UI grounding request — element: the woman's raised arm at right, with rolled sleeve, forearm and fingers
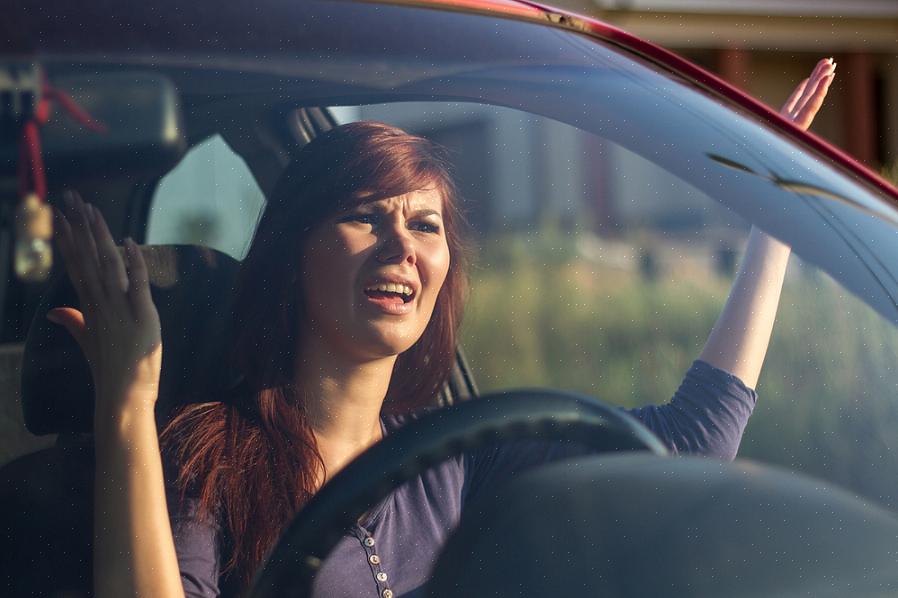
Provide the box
[630,59,835,459]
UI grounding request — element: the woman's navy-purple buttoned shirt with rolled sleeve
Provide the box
[168,361,757,598]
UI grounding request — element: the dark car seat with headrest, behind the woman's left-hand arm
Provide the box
[0,245,476,598]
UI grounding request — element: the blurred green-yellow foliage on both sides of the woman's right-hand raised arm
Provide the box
[462,234,898,506]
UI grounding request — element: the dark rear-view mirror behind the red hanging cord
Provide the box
[0,68,186,179]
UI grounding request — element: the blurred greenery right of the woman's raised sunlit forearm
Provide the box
[743,272,898,506]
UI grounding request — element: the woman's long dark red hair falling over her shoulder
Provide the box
[162,122,466,589]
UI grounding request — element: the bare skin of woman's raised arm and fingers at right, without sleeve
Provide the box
[699,59,836,388]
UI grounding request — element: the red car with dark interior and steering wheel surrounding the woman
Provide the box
[0,0,898,598]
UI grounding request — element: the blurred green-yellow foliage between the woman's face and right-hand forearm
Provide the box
[463,232,726,405]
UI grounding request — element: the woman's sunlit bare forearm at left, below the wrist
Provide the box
[94,390,183,597]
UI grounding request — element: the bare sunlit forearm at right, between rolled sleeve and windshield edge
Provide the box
[699,227,791,388]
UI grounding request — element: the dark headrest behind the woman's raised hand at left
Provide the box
[22,245,239,434]
